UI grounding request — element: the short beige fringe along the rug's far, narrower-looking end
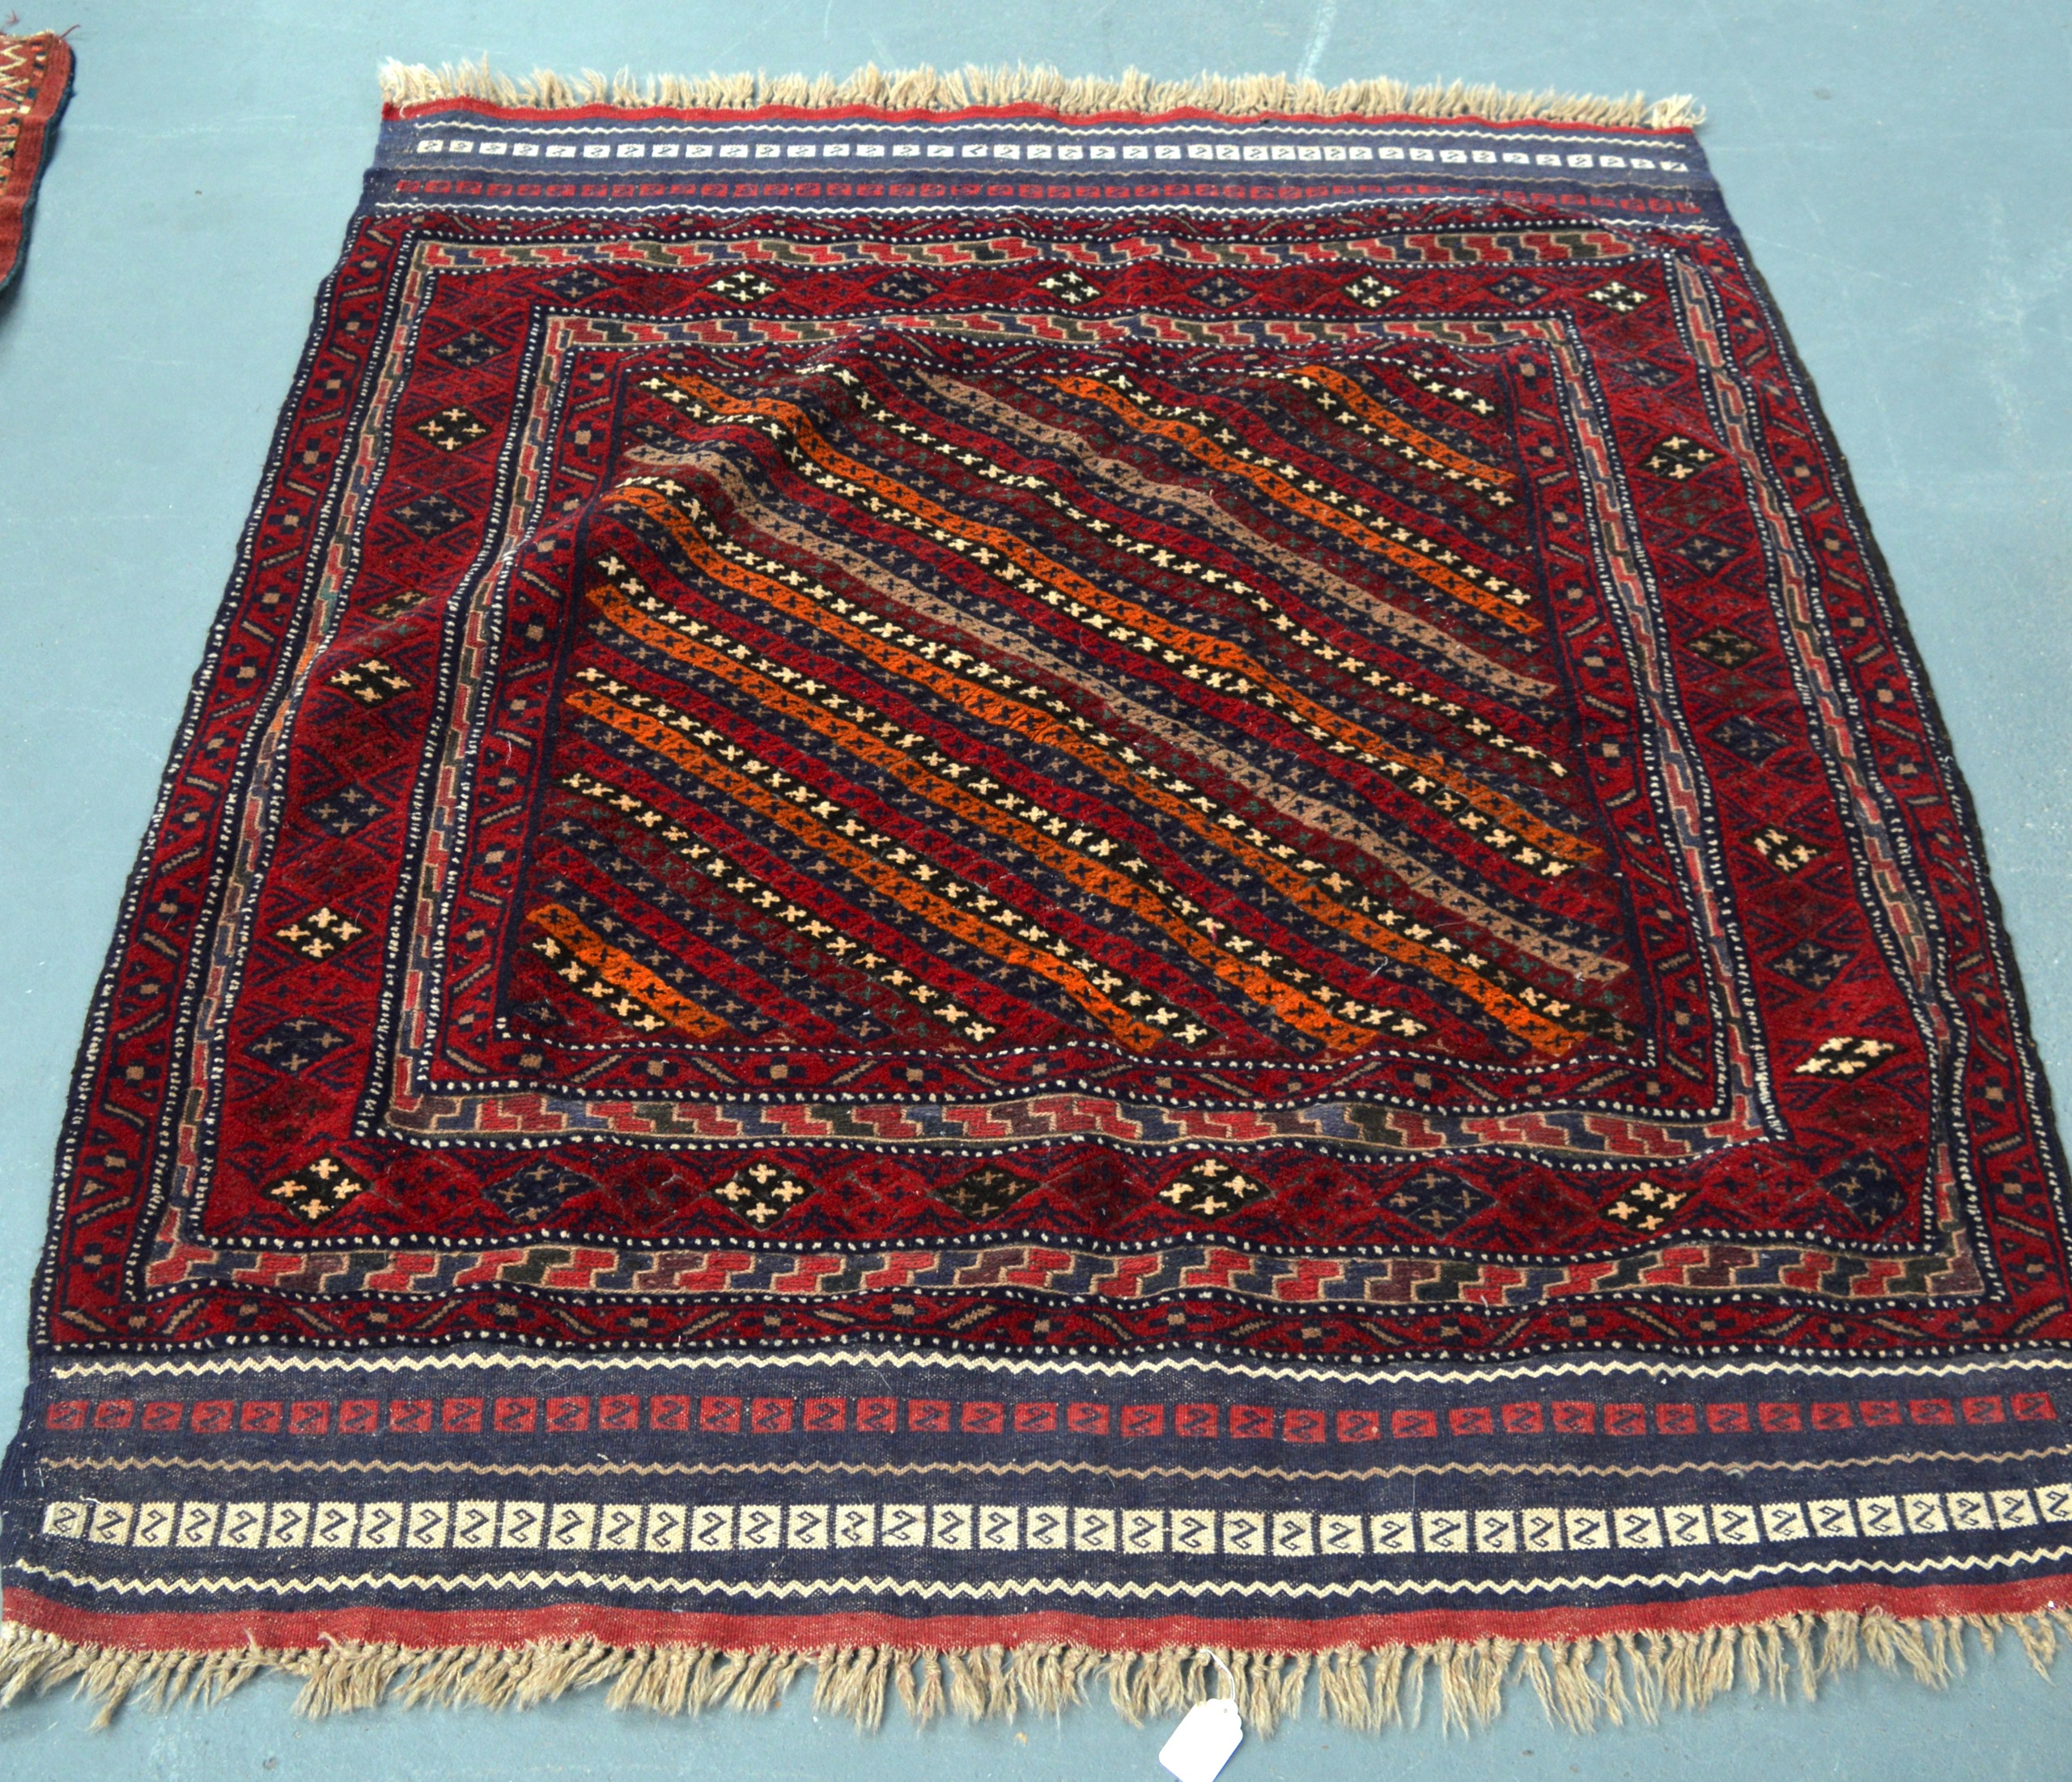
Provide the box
[381,56,1705,130]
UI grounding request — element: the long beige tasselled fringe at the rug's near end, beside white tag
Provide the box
[0,1608,2072,1734]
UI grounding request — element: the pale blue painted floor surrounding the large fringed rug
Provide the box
[0,0,2072,1782]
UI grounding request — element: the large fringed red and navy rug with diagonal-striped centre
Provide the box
[0,70,2072,1726]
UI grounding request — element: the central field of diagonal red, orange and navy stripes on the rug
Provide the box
[522,356,1639,1082]
